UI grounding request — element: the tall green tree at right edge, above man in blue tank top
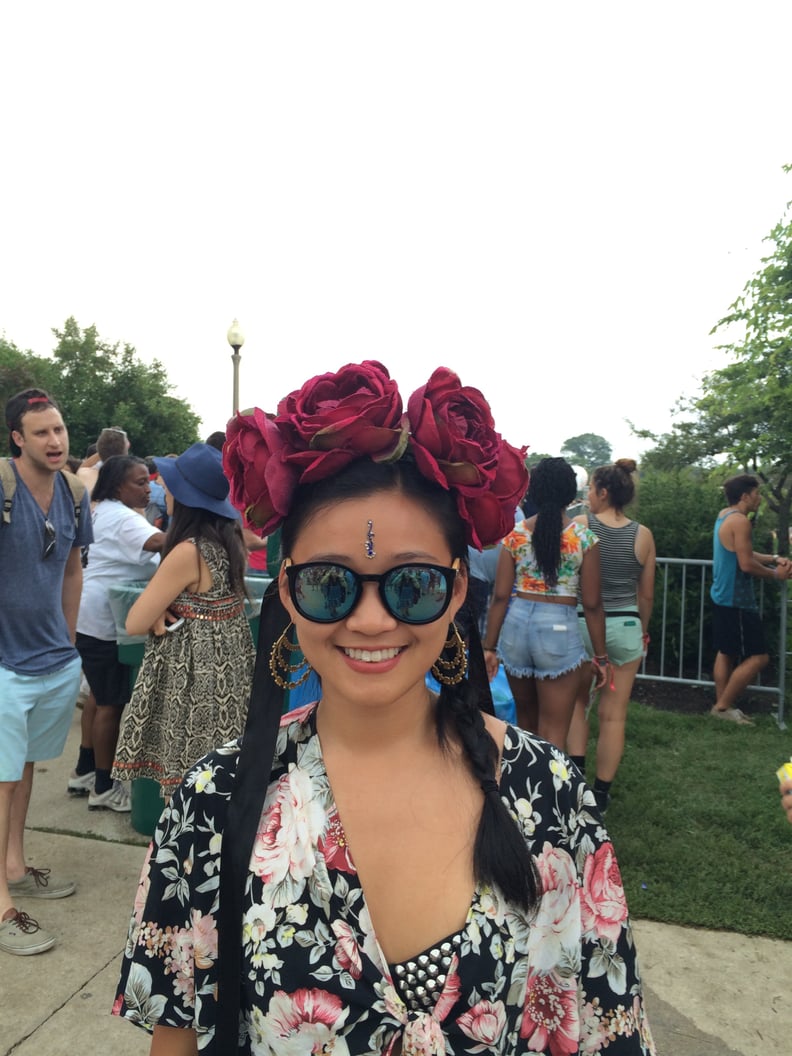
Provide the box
[639,166,792,554]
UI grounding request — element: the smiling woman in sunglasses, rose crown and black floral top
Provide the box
[114,361,655,1056]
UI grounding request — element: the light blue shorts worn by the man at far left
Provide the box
[0,657,82,781]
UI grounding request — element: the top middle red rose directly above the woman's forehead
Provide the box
[276,359,407,484]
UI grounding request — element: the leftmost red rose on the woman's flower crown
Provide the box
[223,408,298,532]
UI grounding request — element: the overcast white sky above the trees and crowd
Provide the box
[0,0,792,457]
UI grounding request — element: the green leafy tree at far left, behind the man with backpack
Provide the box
[0,318,199,456]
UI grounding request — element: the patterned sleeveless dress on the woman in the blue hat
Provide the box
[113,540,256,797]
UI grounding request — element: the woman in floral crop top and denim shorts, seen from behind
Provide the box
[484,458,609,749]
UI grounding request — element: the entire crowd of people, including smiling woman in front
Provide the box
[0,361,792,1056]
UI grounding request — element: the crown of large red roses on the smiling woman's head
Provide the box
[223,359,528,550]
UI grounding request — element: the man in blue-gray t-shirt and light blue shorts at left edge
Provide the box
[0,389,93,955]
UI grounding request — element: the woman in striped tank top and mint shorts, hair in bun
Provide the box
[567,458,655,812]
